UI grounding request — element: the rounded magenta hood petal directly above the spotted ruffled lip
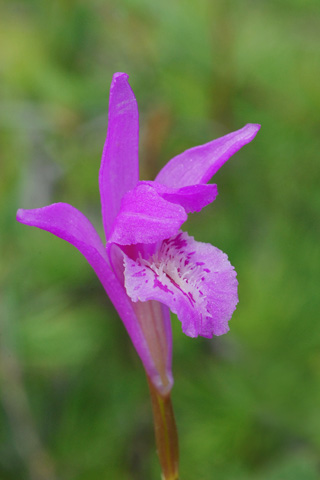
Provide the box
[108,183,187,245]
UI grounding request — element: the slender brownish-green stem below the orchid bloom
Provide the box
[148,378,179,480]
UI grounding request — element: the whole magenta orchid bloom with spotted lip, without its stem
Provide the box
[17,73,260,395]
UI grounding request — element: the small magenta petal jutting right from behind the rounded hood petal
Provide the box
[140,181,218,213]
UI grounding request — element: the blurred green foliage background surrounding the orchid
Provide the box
[0,0,320,480]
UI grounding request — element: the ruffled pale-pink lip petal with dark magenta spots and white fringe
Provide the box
[124,233,238,338]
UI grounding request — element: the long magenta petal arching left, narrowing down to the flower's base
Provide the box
[17,203,173,393]
